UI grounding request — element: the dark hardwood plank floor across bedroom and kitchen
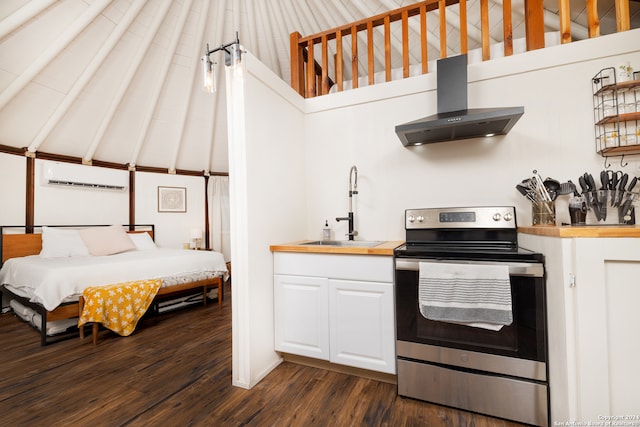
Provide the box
[0,282,520,427]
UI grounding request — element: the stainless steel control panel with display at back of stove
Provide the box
[405,206,517,230]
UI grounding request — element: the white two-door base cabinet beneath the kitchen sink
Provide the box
[274,252,395,374]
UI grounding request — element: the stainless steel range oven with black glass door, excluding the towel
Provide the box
[394,207,549,426]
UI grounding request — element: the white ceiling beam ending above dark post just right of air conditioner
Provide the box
[129,0,193,172]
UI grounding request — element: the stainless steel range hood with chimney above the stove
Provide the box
[396,54,524,146]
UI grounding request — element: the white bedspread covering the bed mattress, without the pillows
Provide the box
[0,249,227,310]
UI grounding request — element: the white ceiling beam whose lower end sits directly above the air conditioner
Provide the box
[85,0,171,166]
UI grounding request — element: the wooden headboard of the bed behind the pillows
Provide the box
[0,224,155,265]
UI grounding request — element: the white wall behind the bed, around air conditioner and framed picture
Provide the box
[0,154,205,248]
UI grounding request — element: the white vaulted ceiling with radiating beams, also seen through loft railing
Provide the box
[0,0,640,172]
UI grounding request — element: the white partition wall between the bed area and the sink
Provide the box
[227,54,306,388]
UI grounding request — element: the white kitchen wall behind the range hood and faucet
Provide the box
[300,30,640,240]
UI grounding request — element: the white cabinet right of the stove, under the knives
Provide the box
[519,234,640,423]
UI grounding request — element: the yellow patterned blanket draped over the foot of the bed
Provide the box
[78,279,162,337]
